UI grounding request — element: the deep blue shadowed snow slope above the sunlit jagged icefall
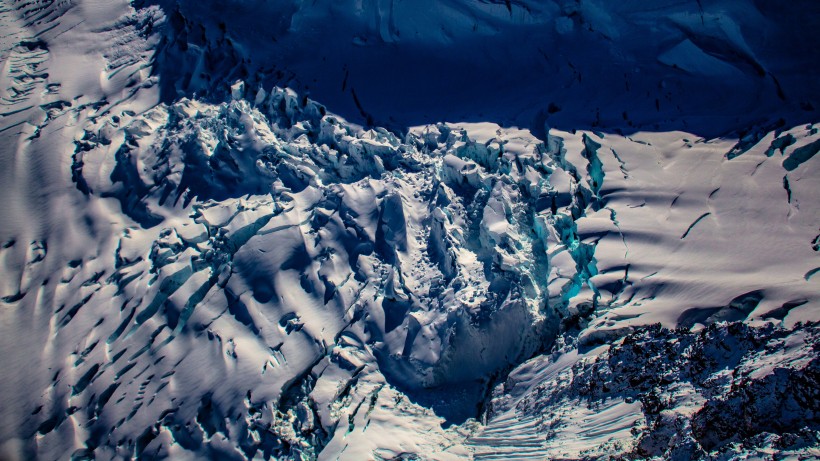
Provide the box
[138,0,820,133]
